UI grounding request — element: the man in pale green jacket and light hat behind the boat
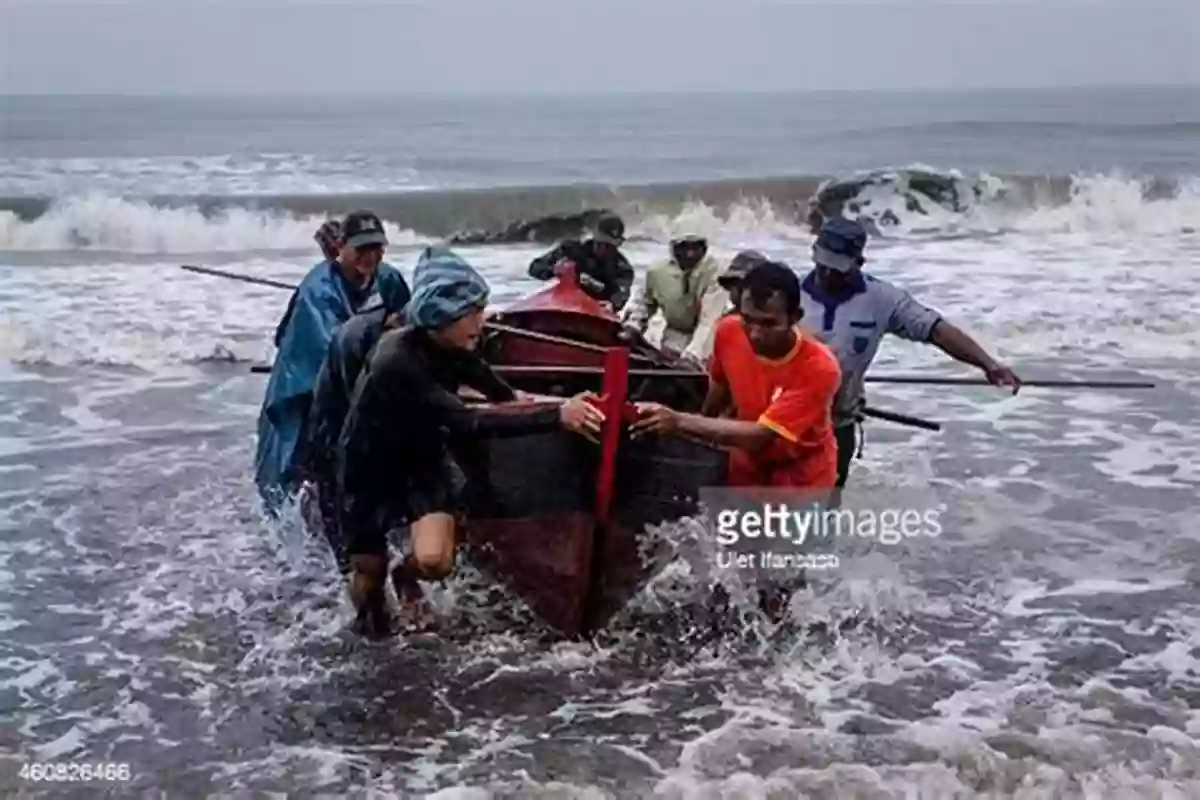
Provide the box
[625,236,725,361]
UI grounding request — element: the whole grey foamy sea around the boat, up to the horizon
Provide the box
[0,90,1200,798]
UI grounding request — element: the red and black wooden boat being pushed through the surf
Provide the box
[453,268,728,636]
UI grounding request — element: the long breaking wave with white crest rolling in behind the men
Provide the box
[0,166,1200,254]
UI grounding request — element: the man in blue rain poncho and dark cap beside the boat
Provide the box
[254,211,408,513]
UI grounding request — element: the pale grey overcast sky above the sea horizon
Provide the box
[0,0,1200,94]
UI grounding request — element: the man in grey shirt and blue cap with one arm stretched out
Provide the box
[800,217,1021,488]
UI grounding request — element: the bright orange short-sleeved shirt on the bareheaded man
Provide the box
[709,317,841,488]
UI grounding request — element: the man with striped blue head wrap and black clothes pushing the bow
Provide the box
[337,247,604,634]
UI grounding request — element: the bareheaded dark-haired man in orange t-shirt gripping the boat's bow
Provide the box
[632,261,841,491]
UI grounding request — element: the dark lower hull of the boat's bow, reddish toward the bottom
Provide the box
[456,410,727,636]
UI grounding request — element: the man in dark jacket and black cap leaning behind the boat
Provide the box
[529,213,634,312]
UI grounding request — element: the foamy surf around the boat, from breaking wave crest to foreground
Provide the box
[0,165,1200,798]
